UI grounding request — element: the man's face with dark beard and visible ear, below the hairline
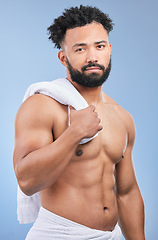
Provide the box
[59,23,111,87]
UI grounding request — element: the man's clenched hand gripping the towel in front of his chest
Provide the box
[70,105,103,138]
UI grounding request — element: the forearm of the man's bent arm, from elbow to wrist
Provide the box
[15,127,81,195]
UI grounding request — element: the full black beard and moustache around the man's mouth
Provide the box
[67,58,111,88]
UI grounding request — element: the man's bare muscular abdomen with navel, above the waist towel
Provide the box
[41,150,118,231]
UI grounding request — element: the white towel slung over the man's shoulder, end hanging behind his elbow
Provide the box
[17,78,97,224]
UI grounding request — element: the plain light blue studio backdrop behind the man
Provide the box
[0,0,158,240]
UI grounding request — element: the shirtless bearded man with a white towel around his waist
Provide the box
[13,5,145,240]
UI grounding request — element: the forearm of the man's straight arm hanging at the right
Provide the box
[118,187,145,240]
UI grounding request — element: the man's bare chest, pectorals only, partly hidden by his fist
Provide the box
[53,104,127,164]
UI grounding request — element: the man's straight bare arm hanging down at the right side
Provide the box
[116,113,145,240]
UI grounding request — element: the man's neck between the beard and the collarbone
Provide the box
[67,78,105,105]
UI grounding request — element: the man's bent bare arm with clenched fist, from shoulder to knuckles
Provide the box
[13,95,102,195]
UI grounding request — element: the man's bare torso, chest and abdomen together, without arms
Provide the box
[41,93,127,231]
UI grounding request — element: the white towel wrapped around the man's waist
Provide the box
[26,207,122,240]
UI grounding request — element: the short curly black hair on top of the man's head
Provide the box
[47,5,114,49]
